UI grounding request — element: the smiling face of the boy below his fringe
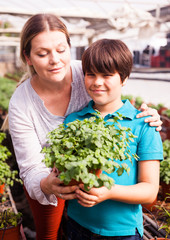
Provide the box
[85,72,126,111]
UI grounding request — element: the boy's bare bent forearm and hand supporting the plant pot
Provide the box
[76,160,160,207]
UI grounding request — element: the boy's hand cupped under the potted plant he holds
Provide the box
[76,184,109,207]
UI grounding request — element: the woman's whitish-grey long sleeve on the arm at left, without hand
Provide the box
[9,102,57,206]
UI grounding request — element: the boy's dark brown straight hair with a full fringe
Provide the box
[82,39,133,82]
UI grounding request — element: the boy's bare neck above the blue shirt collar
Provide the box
[93,100,123,117]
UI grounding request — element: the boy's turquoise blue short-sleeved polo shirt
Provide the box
[65,100,163,236]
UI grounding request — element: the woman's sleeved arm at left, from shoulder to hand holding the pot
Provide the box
[9,104,76,206]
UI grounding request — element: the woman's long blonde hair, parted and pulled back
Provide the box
[1,13,71,131]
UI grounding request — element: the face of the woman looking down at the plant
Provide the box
[26,31,70,82]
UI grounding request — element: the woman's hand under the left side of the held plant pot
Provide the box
[40,169,78,200]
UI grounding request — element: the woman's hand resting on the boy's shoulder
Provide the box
[136,103,162,131]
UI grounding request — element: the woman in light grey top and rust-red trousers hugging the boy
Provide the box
[9,14,161,240]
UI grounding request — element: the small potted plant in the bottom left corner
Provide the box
[0,208,22,240]
